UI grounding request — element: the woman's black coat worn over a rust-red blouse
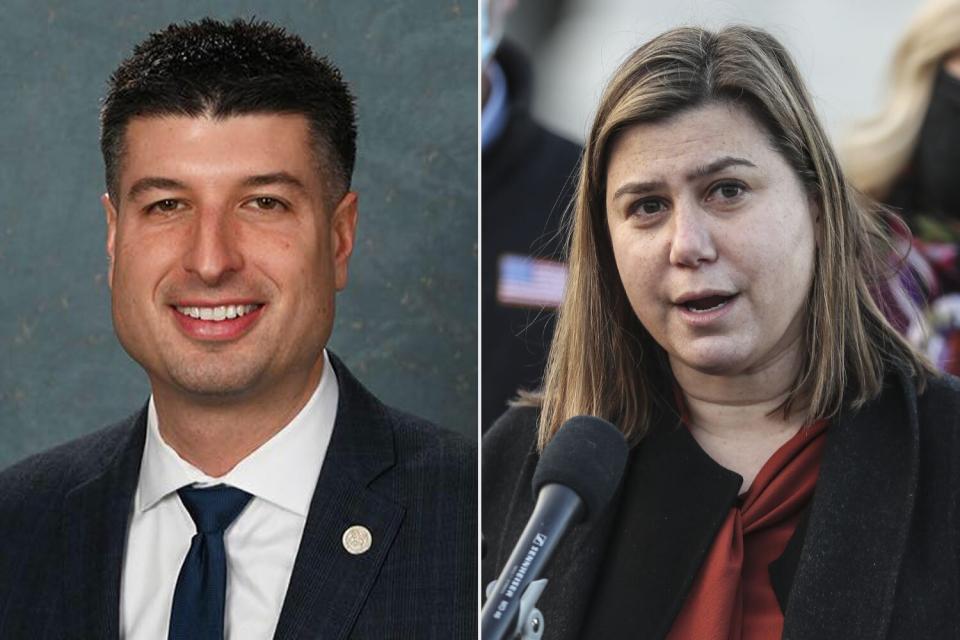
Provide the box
[481,375,960,640]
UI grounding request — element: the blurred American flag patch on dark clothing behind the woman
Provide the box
[497,253,567,307]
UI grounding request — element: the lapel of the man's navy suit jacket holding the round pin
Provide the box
[274,354,404,640]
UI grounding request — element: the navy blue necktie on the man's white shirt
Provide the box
[167,485,251,640]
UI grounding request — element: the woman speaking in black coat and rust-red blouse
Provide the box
[482,27,960,640]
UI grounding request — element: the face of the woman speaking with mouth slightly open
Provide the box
[606,103,817,376]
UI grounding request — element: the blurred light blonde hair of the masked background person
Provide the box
[840,0,960,200]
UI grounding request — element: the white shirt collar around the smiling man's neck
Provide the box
[134,350,339,517]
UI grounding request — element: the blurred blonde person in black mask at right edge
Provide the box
[841,0,960,374]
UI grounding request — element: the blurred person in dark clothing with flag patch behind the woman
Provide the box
[480,0,580,429]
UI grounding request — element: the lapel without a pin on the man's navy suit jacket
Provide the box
[63,408,147,639]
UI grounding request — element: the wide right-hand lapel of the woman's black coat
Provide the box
[783,376,919,639]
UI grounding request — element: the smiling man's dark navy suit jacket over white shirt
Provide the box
[0,357,477,640]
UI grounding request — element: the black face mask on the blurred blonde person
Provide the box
[913,68,960,218]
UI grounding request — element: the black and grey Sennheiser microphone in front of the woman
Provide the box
[480,416,627,640]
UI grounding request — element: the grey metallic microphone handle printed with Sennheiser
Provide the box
[480,484,583,640]
